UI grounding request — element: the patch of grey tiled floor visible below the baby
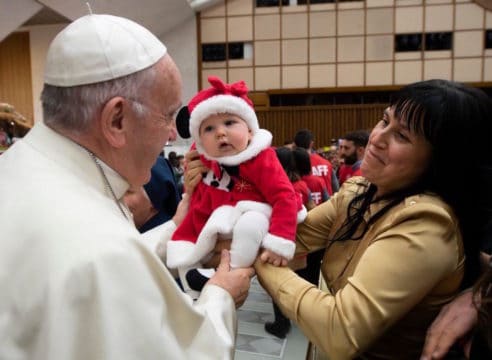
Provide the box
[235,278,308,360]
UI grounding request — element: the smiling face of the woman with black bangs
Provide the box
[361,108,432,197]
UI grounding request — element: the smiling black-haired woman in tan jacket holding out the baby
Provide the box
[255,80,492,360]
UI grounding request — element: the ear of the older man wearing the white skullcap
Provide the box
[100,96,128,148]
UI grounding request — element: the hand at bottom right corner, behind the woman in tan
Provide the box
[420,290,477,360]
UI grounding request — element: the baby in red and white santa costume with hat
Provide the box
[166,76,306,295]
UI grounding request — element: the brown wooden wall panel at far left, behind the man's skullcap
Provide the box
[0,32,33,125]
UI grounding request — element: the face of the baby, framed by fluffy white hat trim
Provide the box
[199,114,252,157]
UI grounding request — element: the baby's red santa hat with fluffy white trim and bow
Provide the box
[188,76,271,165]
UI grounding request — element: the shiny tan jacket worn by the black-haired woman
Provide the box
[255,177,464,360]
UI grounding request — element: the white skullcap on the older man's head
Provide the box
[44,15,166,87]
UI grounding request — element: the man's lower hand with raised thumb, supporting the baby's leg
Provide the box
[207,250,255,308]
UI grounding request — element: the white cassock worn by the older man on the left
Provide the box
[0,123,236,360]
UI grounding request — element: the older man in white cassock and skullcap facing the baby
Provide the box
[0,14,254,360]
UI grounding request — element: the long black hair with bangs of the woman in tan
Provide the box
[333,80,492,286]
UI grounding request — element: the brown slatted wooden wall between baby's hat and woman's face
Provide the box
[256,104,387,148]
